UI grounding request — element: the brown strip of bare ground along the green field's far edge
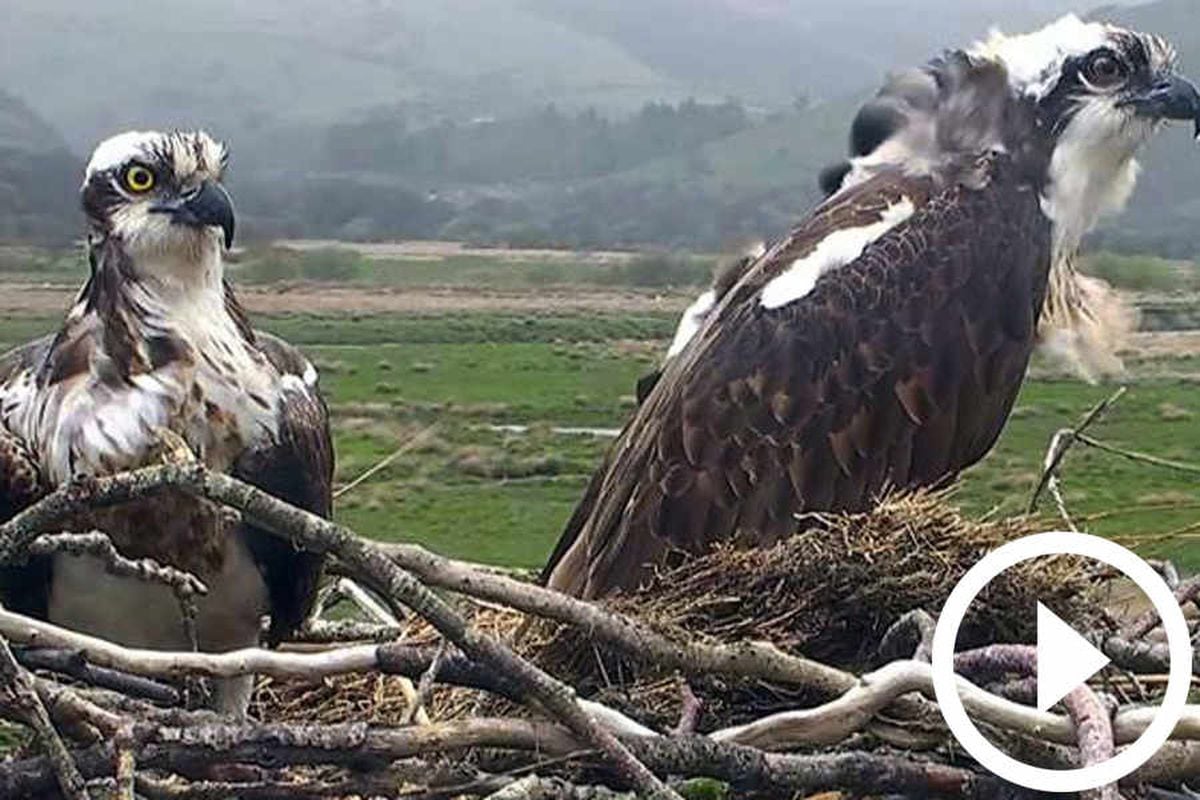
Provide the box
[0,283,692,314]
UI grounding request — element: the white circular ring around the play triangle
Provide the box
[931,531,1192,792]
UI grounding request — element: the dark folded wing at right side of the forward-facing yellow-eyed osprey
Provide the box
[234,332,334,644]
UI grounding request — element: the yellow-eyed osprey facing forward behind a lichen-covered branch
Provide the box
[0,132,334,712]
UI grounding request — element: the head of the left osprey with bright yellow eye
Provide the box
[82,131,234,261]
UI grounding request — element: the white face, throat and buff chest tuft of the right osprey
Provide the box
[972,16,1200,379]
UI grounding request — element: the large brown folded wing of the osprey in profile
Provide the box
[548,158,1050,597]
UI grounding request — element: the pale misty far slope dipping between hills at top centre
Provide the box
[532,0,1123,107]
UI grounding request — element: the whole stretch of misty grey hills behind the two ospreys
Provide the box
[9,0,1200,254]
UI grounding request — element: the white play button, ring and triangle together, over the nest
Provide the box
[931,531,1192,793]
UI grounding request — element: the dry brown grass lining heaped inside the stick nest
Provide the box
[259,493,1104,729]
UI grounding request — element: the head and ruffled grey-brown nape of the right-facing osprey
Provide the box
[822,16,1200,237]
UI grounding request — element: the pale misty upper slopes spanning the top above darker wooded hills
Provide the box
[0,0,1132,151]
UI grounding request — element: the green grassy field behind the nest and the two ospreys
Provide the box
[0,313,1200,570]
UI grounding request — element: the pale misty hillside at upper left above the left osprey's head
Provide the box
[0,0,688,151]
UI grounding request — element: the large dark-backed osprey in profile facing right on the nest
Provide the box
[544,16,1200,597]
